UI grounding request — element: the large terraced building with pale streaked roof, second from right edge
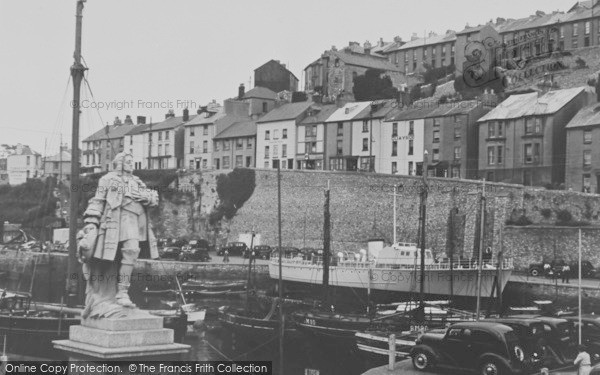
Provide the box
[478,87,587,186]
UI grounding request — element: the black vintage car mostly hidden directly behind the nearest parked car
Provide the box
[484,317,546,369]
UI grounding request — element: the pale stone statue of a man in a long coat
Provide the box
[80,152,158,318]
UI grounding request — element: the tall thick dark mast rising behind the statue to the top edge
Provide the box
[66,0,87,307]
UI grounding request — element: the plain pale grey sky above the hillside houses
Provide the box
[0,0,575,154]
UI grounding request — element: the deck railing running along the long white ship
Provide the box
[271,255,514,271]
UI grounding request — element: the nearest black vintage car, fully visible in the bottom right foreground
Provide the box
[410,322,525,375]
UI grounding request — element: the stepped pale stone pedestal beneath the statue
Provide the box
[53,312,190,373]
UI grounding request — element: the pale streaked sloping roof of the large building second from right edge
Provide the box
[478,87,585,122]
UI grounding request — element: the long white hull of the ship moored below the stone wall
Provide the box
[269,262,512,297]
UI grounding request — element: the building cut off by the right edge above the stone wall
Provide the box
[565,103,600,194]
